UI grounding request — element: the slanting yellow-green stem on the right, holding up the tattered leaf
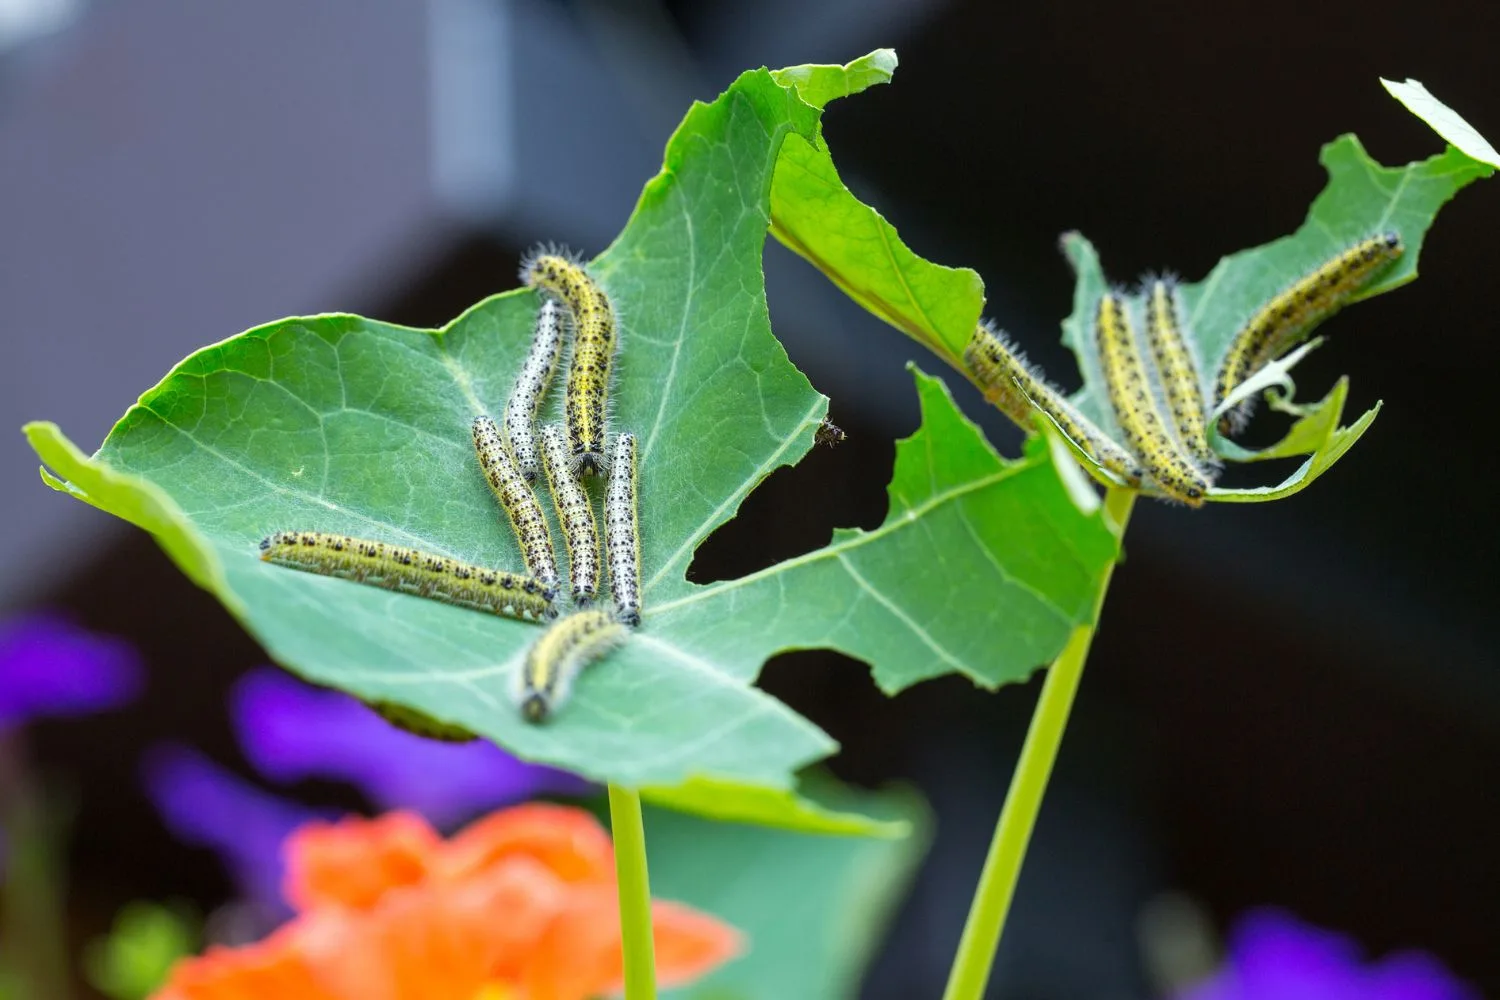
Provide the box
[942,489,1136,1000]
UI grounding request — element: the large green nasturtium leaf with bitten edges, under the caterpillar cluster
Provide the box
[27,56,1118,815]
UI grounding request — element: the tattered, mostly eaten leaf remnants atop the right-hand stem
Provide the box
[771,52,1493,502]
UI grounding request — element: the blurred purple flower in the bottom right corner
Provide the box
[1178,909,1479,1000]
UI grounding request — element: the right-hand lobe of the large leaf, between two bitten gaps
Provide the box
[657,365,1119,693]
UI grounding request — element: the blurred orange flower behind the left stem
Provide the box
[155,804,741,1000]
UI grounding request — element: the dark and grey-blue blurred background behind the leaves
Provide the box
[0,0,1500,1000]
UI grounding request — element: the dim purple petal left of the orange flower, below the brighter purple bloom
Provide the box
[143,744,332,921]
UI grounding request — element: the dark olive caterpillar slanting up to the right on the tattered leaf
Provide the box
[1214,231,1406,433]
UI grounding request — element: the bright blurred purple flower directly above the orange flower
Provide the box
[231,667,590,826]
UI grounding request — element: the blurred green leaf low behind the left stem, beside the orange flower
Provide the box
[647,792,930,1000]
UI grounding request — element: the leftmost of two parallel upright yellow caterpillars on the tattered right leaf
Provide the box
[1094,292,1209,507]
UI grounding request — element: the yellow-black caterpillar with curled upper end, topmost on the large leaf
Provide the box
[522,245,617,475]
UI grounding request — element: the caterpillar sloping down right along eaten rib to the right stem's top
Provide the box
[963,322,1143,486]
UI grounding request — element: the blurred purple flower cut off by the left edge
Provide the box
[0,615,141,730]
